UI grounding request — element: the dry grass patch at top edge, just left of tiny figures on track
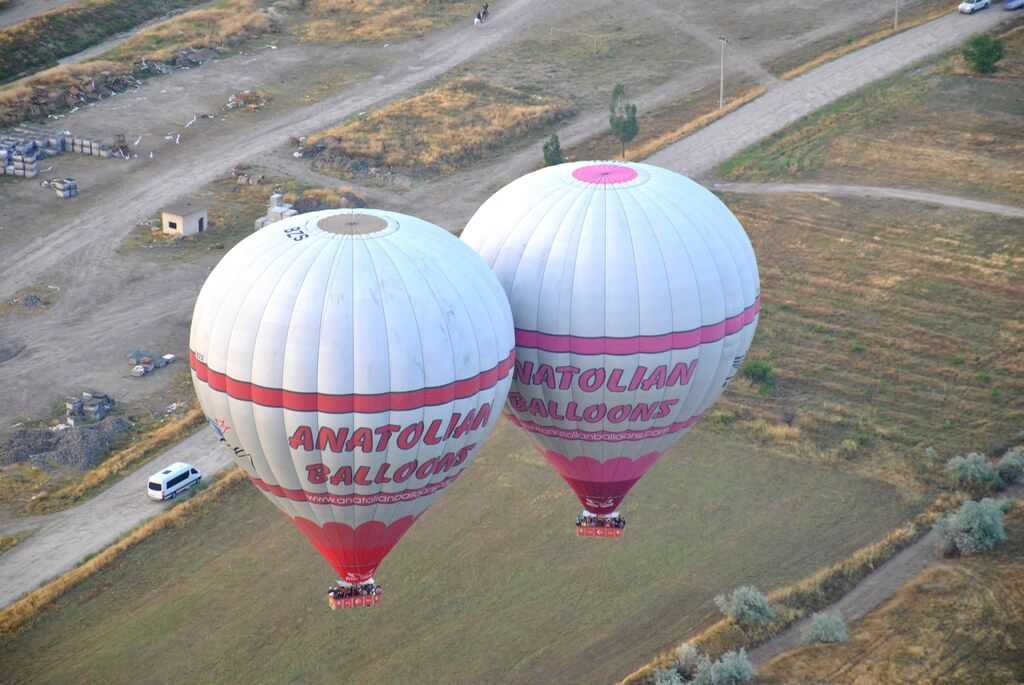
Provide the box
[292,0,480,42]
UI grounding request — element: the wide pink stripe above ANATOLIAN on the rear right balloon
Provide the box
[515,296,761,354]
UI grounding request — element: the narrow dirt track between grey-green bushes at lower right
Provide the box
[748,483,1024,665]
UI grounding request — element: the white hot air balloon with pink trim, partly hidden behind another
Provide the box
[462,162,760,537]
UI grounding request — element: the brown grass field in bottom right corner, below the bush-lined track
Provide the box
[758,507,1024,685]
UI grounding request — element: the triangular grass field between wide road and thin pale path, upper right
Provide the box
[720,27,1024,205]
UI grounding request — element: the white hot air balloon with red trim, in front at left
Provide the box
[189,209,515,606]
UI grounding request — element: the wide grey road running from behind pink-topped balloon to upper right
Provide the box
[646,9,1010,178]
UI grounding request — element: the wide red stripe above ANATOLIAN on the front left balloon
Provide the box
[188,350,515,414]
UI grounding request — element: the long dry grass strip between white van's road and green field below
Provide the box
[0,469,245,644]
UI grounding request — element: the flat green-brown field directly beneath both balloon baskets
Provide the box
[0,424,918,683]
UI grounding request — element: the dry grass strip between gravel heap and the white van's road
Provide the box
[25,405,206,514]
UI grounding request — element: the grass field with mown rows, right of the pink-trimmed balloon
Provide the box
[710,195,1024,487]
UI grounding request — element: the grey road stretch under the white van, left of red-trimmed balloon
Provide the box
[0,430,231,608]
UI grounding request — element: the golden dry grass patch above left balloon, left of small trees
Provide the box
[306,77,570,175]
